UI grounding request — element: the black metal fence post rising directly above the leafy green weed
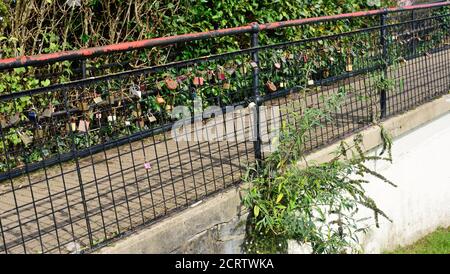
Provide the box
[251,23,262,167]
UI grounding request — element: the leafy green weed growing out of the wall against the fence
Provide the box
[243,86,395,253]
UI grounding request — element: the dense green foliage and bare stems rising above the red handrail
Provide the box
[0,0,389,57]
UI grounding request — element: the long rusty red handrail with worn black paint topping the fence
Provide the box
[0,1,450,70]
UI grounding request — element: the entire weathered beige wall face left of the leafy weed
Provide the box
[97,186,247,254]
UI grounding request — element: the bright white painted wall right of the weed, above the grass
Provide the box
[361,113,450,253]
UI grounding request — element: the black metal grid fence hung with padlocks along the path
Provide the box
[0,3,450,253]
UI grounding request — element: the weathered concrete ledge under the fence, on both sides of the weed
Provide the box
[95,95,450,253]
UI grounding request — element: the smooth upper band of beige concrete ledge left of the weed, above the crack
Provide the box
[95,187,245,254]
